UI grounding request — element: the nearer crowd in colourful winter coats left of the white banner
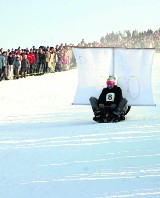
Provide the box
[0,44,74,81]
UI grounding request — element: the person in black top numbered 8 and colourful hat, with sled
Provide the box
[89,76,130,123]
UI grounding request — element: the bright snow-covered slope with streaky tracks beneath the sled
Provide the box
[0,54,160,198]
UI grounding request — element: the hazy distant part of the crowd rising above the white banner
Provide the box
[78,28,160,51]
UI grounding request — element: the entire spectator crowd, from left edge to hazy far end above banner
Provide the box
[0,28,160,81]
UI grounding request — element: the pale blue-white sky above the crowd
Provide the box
[0,0,160,49]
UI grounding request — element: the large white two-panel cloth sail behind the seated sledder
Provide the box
[73,48,154,106]
